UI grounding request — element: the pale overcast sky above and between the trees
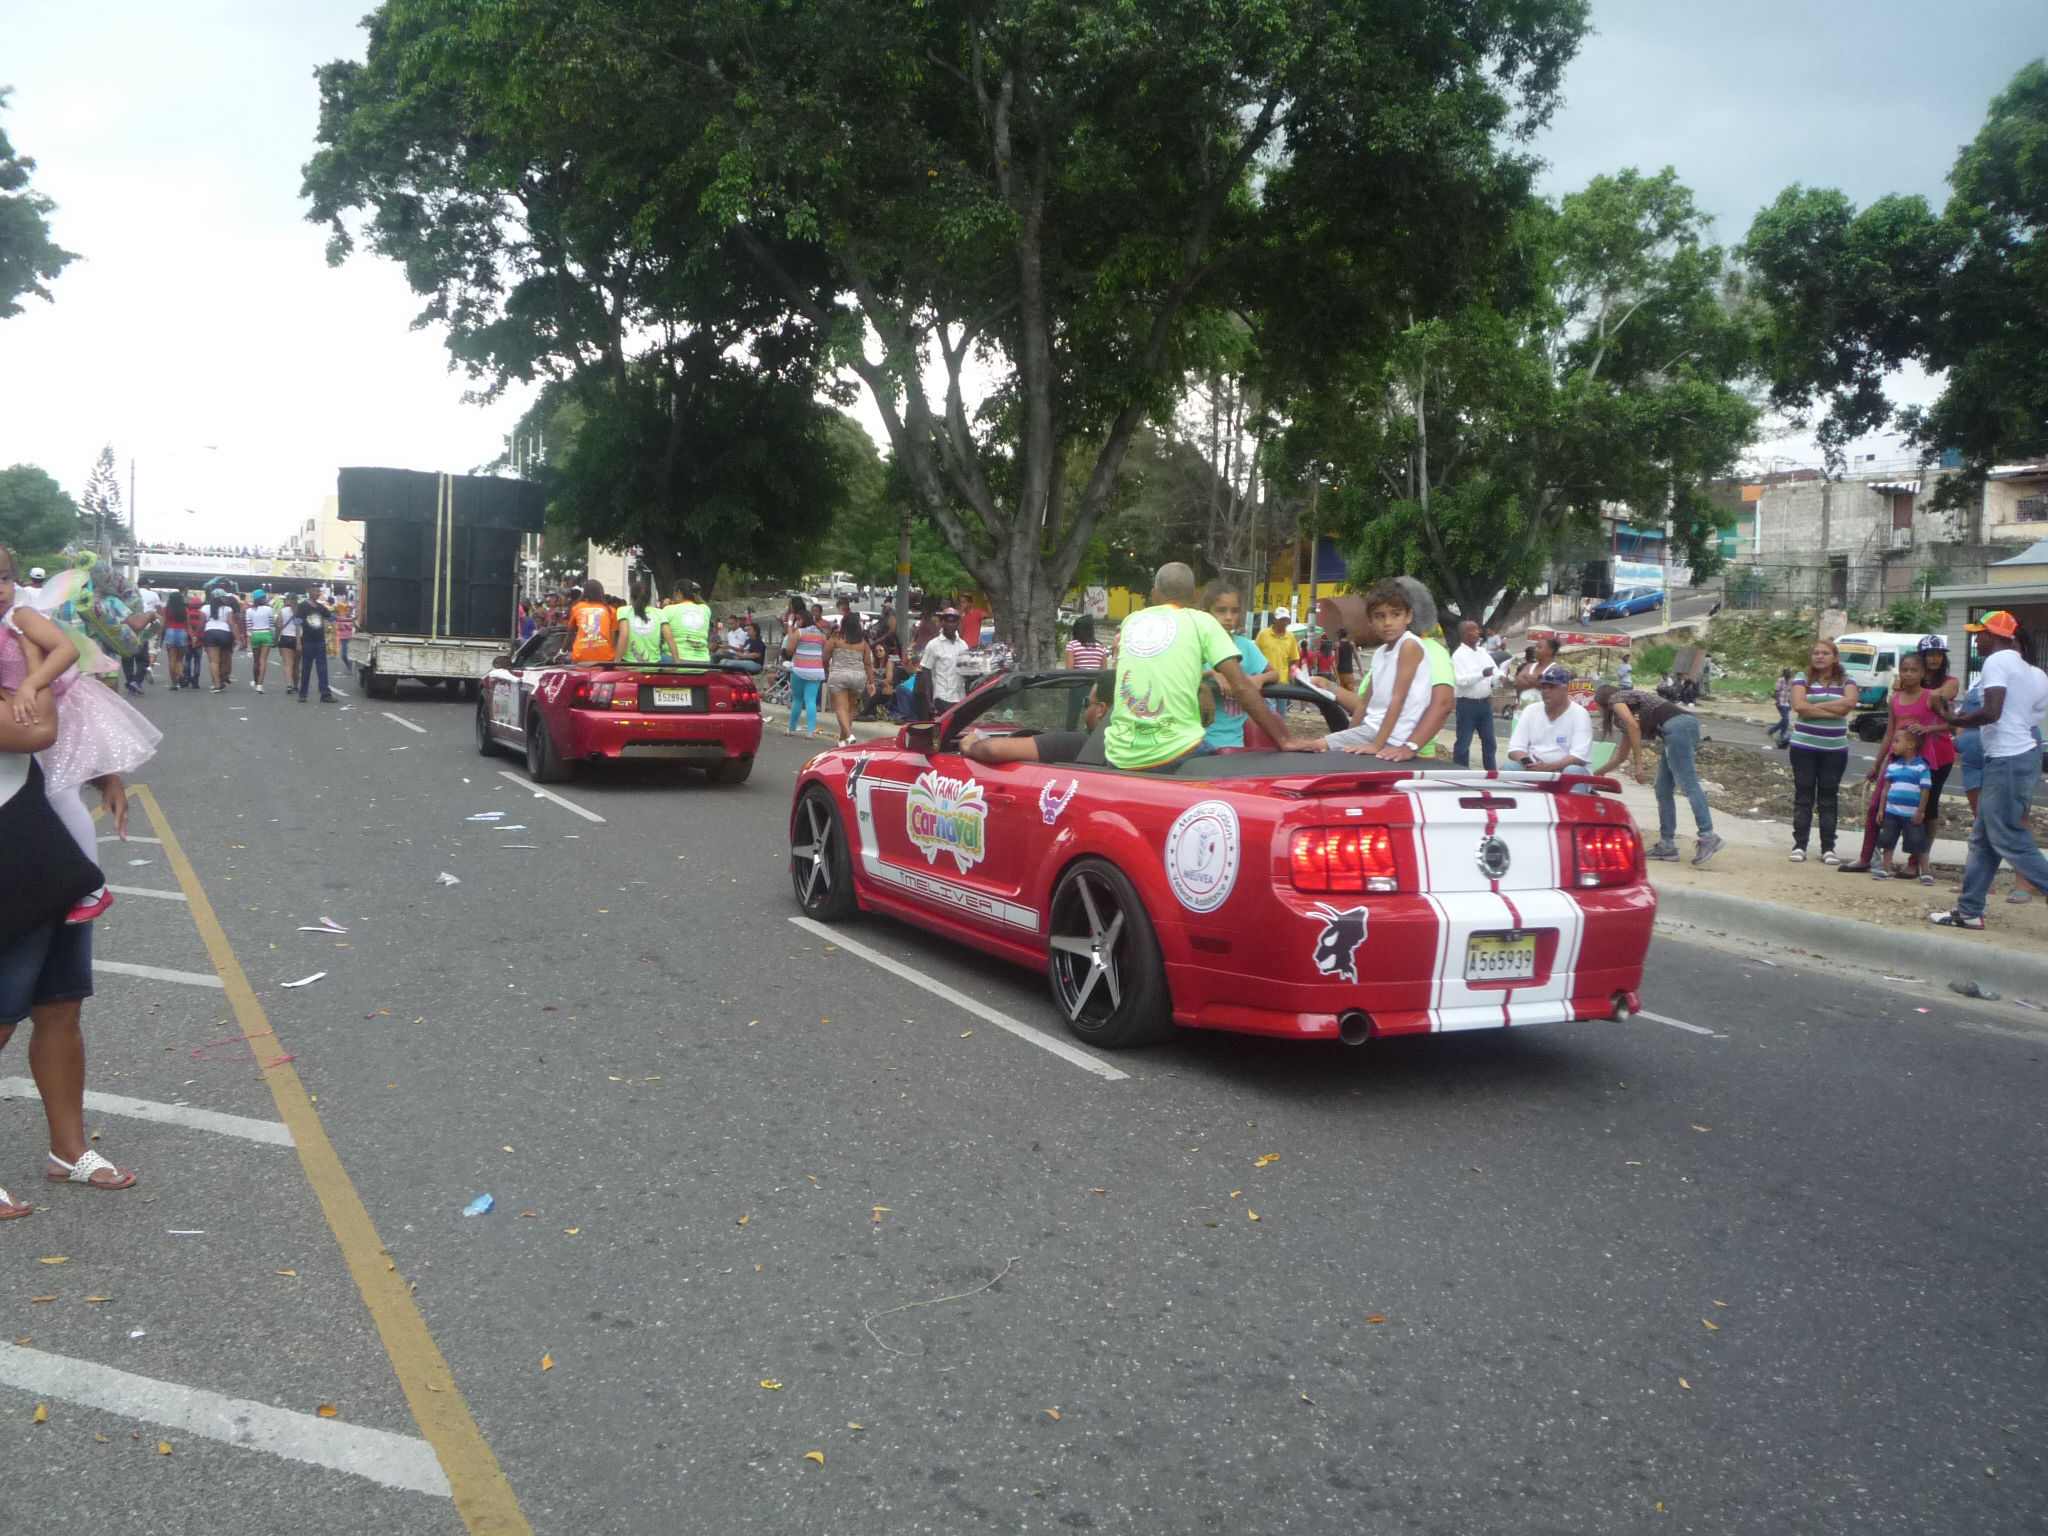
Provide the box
[0,0,2048,543]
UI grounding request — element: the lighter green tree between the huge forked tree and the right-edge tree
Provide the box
[1280,168,1757,623]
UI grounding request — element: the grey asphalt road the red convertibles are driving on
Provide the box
[0,682,2048,1536]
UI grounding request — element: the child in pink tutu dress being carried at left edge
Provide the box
[0,549,164,922]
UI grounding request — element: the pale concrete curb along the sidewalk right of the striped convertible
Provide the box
[1657,885,2048,1004]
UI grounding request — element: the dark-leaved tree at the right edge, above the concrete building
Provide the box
[1743,59,2048,498]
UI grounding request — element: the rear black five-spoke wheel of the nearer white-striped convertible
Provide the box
[1047,858,1174,1051]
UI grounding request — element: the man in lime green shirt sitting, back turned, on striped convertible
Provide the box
[1102,561,1311,768]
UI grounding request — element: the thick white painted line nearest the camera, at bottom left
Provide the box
[0,1343,453,1499]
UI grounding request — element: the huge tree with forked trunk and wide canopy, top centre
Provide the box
[307,0,1585,662]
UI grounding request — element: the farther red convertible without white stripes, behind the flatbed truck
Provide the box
[477,629,762,784]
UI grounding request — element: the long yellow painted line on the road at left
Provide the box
[129,786,532,1536]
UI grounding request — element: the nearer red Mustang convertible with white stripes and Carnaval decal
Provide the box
[791,672,1657,1047]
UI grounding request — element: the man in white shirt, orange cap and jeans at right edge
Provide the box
[1927,608,2048,928]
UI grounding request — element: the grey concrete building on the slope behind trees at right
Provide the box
[1716,463,2048,612]
